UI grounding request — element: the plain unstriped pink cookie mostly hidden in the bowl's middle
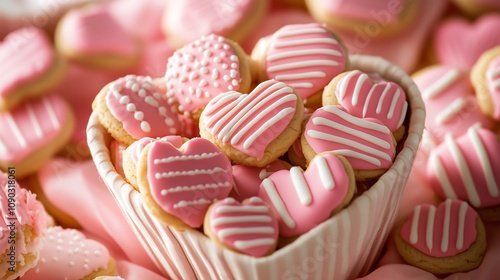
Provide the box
[229,160,291,201]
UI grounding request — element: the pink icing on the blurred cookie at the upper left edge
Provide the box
[0,27,55,98]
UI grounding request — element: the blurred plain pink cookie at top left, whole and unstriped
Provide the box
[55,6,141,71]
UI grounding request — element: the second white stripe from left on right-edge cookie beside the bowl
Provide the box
[445,133,481,207]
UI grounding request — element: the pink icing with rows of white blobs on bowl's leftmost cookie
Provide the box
[106,75,181,139]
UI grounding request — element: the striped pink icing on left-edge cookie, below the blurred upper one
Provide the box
[0,94,68,162]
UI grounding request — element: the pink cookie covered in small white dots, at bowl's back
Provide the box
[165,34,251,119]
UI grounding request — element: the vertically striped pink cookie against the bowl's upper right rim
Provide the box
[323,70,408,141]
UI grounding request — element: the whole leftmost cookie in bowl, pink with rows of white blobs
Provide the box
[92,75,181,145]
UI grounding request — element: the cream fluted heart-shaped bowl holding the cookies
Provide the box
[87,55,425,279]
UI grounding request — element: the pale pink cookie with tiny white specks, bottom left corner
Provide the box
[23,227,115,280]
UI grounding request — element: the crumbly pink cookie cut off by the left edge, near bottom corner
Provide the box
[0,171,47,280]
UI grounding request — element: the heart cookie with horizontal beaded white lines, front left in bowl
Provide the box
[137,138,233,229]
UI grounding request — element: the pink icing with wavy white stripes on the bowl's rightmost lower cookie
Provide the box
[303,105,396,170]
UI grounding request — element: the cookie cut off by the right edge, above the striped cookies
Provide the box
[470,46,500,121]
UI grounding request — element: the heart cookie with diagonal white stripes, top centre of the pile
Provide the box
[200,80,304,167]
